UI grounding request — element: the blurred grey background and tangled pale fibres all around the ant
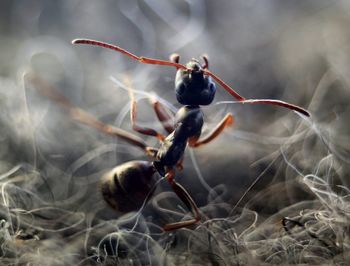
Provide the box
[0,0,350,265]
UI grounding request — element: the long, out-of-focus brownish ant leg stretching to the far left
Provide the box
[25,72,156,157]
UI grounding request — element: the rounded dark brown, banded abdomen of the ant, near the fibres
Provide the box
[101,161,159,213]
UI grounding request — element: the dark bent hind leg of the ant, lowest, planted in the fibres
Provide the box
[163,170,201,231]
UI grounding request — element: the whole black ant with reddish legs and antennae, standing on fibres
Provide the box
[30,39,310,231]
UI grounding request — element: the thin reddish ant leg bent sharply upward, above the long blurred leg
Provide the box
[125,77,165,141]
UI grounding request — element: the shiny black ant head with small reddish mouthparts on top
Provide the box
[170,55,216,105]
